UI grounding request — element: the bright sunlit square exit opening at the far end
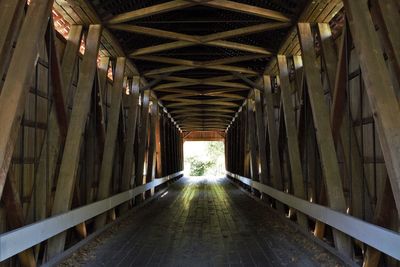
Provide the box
[183,141,225,178]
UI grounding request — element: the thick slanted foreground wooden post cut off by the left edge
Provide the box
[0,0,53,201]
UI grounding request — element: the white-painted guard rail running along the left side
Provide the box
[0,171,183,262]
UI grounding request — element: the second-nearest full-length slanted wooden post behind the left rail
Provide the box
[95,57,126,229]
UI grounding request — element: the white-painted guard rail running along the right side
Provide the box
[226,171,400,260]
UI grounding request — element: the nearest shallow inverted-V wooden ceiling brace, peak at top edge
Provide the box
[107,0,291,24]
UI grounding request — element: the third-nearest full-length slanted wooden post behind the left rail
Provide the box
[121,76,140,213]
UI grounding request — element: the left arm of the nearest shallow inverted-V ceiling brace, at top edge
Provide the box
[107,0,196,24]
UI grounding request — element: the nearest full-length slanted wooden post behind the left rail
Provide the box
[47,25,102,258]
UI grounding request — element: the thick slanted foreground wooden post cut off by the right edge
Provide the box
[343,0,400,216]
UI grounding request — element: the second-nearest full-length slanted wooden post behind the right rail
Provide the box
[276,62,308,229]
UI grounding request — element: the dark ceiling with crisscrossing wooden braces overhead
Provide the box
[91,0,307,131]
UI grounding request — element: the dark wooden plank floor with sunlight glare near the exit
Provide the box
[62,178,350,266]
